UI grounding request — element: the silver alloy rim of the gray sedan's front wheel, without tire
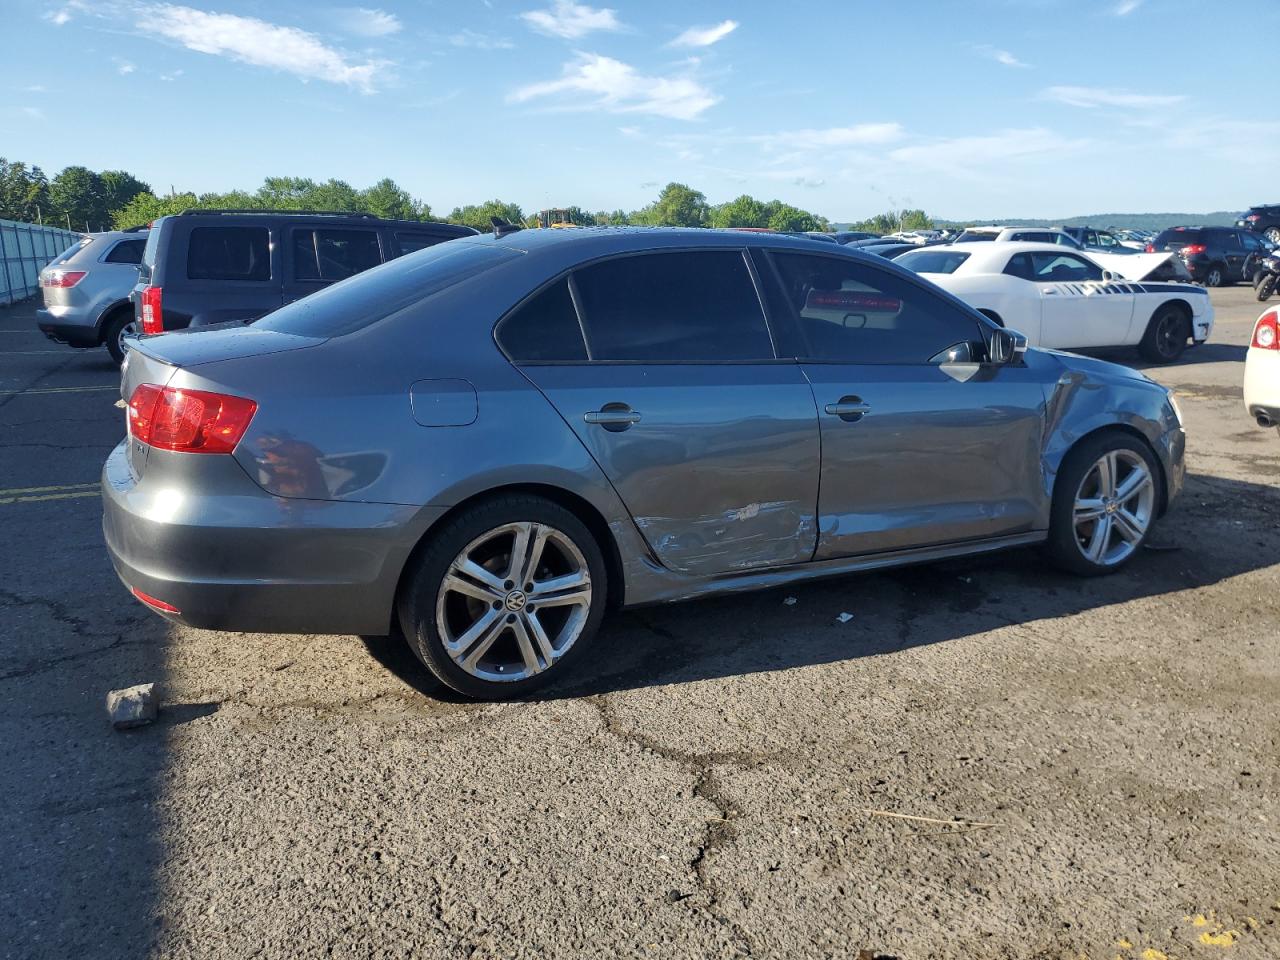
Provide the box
[1071,449,1156,567]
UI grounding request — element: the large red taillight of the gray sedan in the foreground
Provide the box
[129,383,257,453]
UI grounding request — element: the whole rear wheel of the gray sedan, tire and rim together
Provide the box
[398,494,608,700]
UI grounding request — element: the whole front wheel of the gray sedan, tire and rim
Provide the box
[1044,431,1161,576]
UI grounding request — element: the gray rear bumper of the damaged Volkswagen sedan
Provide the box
[102,440,445,634]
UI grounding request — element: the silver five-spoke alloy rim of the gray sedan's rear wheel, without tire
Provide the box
[435,522,591,681]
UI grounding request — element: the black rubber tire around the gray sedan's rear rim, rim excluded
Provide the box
[398,495,608,700]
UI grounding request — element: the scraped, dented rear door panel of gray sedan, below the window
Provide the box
[524,362,820,576]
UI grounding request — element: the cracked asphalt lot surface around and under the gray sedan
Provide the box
[0,295,1280,960]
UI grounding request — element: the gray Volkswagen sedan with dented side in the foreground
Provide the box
[102,228,1184,698]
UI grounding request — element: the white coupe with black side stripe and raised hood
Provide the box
[895,243,1213,364]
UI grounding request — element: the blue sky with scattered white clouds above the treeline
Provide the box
[0,0,1280,220]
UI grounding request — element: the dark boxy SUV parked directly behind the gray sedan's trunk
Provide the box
[129,210,476,333]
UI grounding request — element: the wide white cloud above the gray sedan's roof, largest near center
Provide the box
[507,54,719,120]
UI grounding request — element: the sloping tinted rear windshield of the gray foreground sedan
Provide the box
[255,243,520,338]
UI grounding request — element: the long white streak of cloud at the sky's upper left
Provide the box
[136,4,388,93]
